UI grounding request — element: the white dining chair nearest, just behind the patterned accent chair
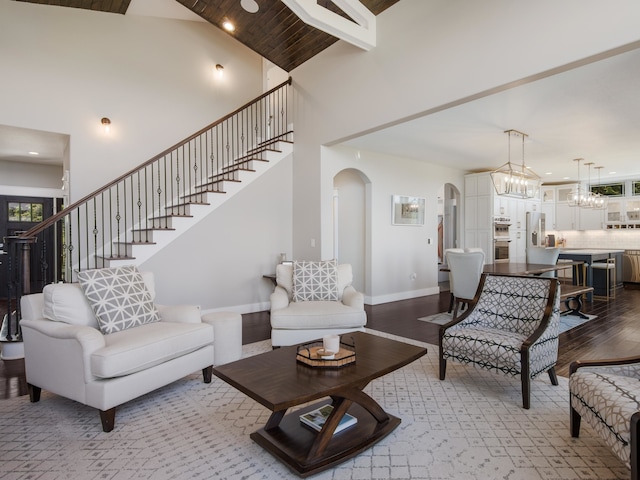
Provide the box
[447,251,484,318]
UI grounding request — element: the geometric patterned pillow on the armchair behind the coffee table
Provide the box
[293,259,338,302]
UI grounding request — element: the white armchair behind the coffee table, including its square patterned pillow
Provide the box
[271,261,367,347]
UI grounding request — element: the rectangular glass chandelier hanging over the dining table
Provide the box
[491,130,541,198]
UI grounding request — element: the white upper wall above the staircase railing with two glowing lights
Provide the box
[0,0,262,201]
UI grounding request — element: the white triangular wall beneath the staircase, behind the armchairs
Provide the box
[140,157,292,313]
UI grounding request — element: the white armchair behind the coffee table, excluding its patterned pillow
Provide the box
[270,262,367,347]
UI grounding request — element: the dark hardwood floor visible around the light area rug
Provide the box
[0,286,640,398]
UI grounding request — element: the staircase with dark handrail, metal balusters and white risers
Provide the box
[7,78,293,306]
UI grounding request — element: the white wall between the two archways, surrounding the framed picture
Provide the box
[324,146,464,305]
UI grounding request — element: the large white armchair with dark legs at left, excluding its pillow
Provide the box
[20,273,214,432]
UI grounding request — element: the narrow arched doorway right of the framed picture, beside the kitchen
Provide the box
[438,183,462,282]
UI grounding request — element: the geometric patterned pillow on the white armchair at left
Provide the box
[78,265,160,334]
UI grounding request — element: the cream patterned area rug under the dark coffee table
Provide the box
[0,332,629,480]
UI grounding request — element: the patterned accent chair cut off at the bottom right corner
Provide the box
[569,356,640,480]
